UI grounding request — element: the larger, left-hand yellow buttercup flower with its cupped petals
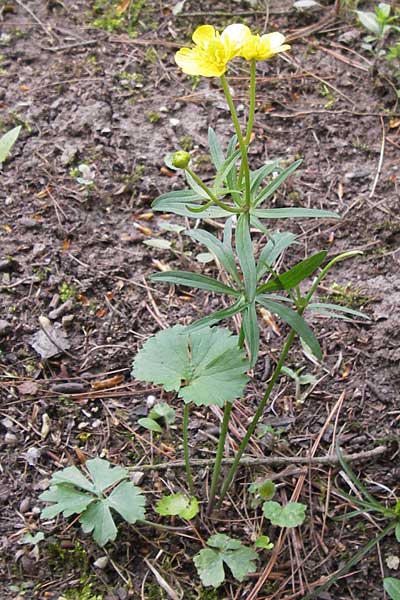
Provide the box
[175,23,251,77]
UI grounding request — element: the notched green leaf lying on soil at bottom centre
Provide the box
[193,533,257,588]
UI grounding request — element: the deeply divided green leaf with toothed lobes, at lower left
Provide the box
[40,458,145,546]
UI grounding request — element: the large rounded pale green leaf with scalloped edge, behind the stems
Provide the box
[132,325,248,406]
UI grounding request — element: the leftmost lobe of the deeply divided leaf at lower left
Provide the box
[39,483,95,519]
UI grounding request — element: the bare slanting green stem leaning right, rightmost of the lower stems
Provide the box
[217,329,296,506]
